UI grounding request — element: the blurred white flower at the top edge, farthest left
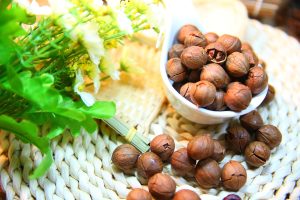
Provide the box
[14,0,52,16]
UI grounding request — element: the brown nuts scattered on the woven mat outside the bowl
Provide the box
[112,106,282,200]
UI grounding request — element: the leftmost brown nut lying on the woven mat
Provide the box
[111,144,140,173]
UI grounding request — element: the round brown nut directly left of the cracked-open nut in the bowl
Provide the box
[180,46,207,69]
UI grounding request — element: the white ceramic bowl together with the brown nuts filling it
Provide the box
[160,17,268,124]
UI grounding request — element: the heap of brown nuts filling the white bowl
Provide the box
[166,25,268,112]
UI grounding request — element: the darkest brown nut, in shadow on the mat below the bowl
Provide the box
[225,124,251,154]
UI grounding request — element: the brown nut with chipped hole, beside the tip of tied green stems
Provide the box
[150,134,175,161]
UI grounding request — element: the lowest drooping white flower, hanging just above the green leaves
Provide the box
[74,69,96,106]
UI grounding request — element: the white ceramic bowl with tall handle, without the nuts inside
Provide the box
[160,1,268,124]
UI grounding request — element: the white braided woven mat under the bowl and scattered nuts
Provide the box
[0,21,300,200]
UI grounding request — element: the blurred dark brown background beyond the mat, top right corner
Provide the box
[242,0,300,41]
